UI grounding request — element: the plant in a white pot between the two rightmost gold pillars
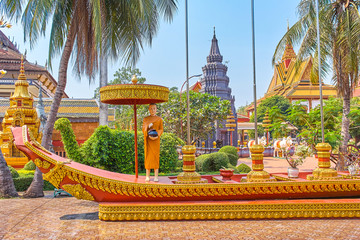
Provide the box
[282,145,312,178]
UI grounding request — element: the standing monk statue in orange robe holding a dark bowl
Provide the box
[142,103,164,182]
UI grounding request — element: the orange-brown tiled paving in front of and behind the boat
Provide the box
[0,158,360,240]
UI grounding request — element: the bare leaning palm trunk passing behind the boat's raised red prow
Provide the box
[23,29,74,198]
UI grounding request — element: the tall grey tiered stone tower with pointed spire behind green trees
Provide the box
[198,28,237,147]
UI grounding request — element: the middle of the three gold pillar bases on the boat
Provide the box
[246,145,275,182]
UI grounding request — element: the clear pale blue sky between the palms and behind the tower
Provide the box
[3,0,299,107]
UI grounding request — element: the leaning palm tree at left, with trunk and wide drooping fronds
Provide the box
[0,0,176,196]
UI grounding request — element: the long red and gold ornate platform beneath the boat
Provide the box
[99,198,360,221]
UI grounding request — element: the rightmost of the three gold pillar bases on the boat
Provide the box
[307,143,341,180]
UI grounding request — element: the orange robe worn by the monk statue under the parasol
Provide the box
[142,116,164,169]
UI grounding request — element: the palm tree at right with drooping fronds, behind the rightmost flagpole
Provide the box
[273,0,360,169]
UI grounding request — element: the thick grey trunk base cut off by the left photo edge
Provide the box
[0,151,19,198]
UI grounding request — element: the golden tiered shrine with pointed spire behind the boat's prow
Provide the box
[0,57,42,168]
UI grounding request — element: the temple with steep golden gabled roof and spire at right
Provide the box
[246,29,337,116]
